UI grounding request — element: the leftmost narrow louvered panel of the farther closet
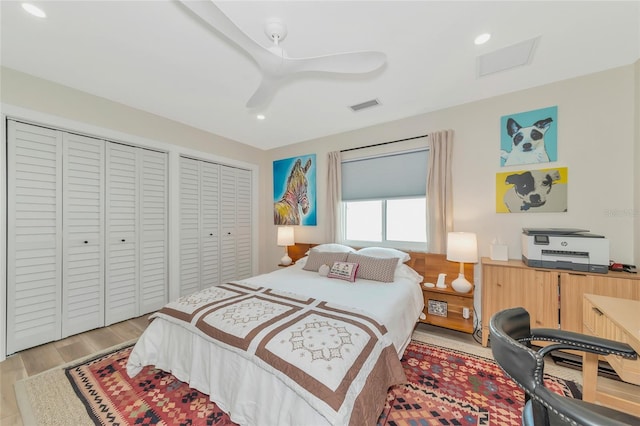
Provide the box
[180,157,201,296]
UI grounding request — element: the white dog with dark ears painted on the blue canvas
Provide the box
[501,117,553,166]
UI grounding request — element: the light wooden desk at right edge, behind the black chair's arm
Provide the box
[582,294,640,415]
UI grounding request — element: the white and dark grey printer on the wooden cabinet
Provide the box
[522,228,609,274]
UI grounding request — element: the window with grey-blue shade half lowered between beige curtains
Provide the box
[342,149,428,250]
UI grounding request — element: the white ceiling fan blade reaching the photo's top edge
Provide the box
[179,0,274,67]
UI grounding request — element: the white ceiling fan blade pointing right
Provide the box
[285,51,387,74]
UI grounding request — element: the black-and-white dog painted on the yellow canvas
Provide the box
[504,169,567,213]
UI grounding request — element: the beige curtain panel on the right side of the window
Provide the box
[427,130,453,254]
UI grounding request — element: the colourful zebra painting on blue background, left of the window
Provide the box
[273,154,317,226]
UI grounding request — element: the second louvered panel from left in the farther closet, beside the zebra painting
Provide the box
[200,162,220,289]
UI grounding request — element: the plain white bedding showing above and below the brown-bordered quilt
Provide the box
[127,264,424,426]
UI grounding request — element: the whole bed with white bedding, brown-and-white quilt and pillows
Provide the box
[127,244,424,425]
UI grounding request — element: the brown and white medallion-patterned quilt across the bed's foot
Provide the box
[152,282,405,425]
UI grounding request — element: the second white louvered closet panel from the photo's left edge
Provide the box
[62,133,105,337]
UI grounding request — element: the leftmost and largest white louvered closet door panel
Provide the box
[7,121,62,353]
